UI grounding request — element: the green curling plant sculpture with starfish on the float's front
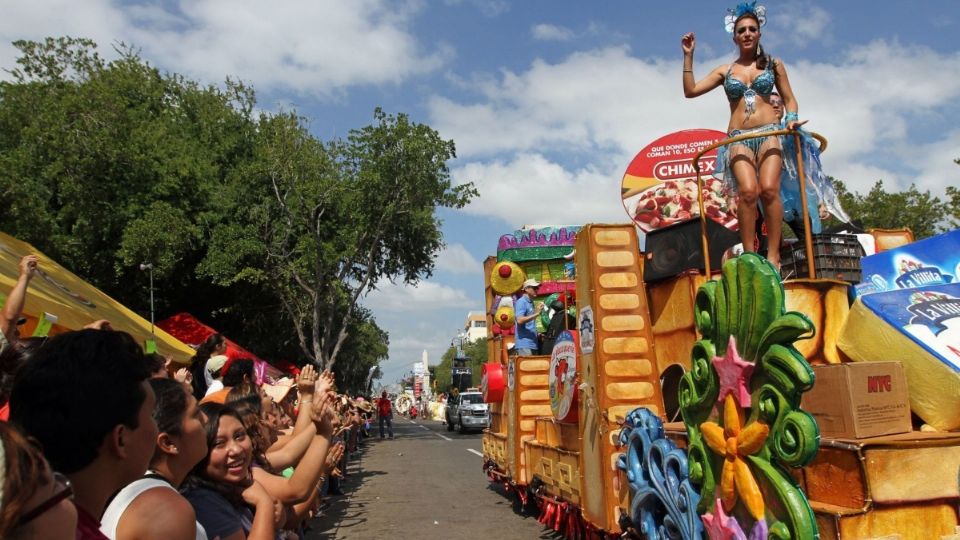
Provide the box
[680,253,820,540]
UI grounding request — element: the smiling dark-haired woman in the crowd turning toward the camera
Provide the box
[184,403,285,540]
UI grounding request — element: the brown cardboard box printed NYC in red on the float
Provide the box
[801,362,912,439]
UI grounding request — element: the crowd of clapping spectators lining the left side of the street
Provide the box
[0,256,382,540]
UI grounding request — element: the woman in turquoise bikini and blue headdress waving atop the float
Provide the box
[681,2,806,269]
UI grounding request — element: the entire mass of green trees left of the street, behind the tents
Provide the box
[0,38,476,378]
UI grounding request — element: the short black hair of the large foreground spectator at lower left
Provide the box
[10,330,150,474]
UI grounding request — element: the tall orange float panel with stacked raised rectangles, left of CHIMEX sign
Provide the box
[576,225,663,533]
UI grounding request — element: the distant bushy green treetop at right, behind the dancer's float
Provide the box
[833,179,956,239]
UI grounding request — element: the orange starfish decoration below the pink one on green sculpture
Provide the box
[700,395,770,520]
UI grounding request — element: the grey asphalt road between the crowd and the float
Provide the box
[306,417,557,540]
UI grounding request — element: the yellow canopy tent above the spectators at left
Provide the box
[0,232,194,364]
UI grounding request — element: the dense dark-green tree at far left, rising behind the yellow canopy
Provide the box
[0,38,312,360]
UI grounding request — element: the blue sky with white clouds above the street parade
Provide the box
[0,0,960,383]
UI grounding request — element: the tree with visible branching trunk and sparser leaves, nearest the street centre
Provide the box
[209,109,476,368]
